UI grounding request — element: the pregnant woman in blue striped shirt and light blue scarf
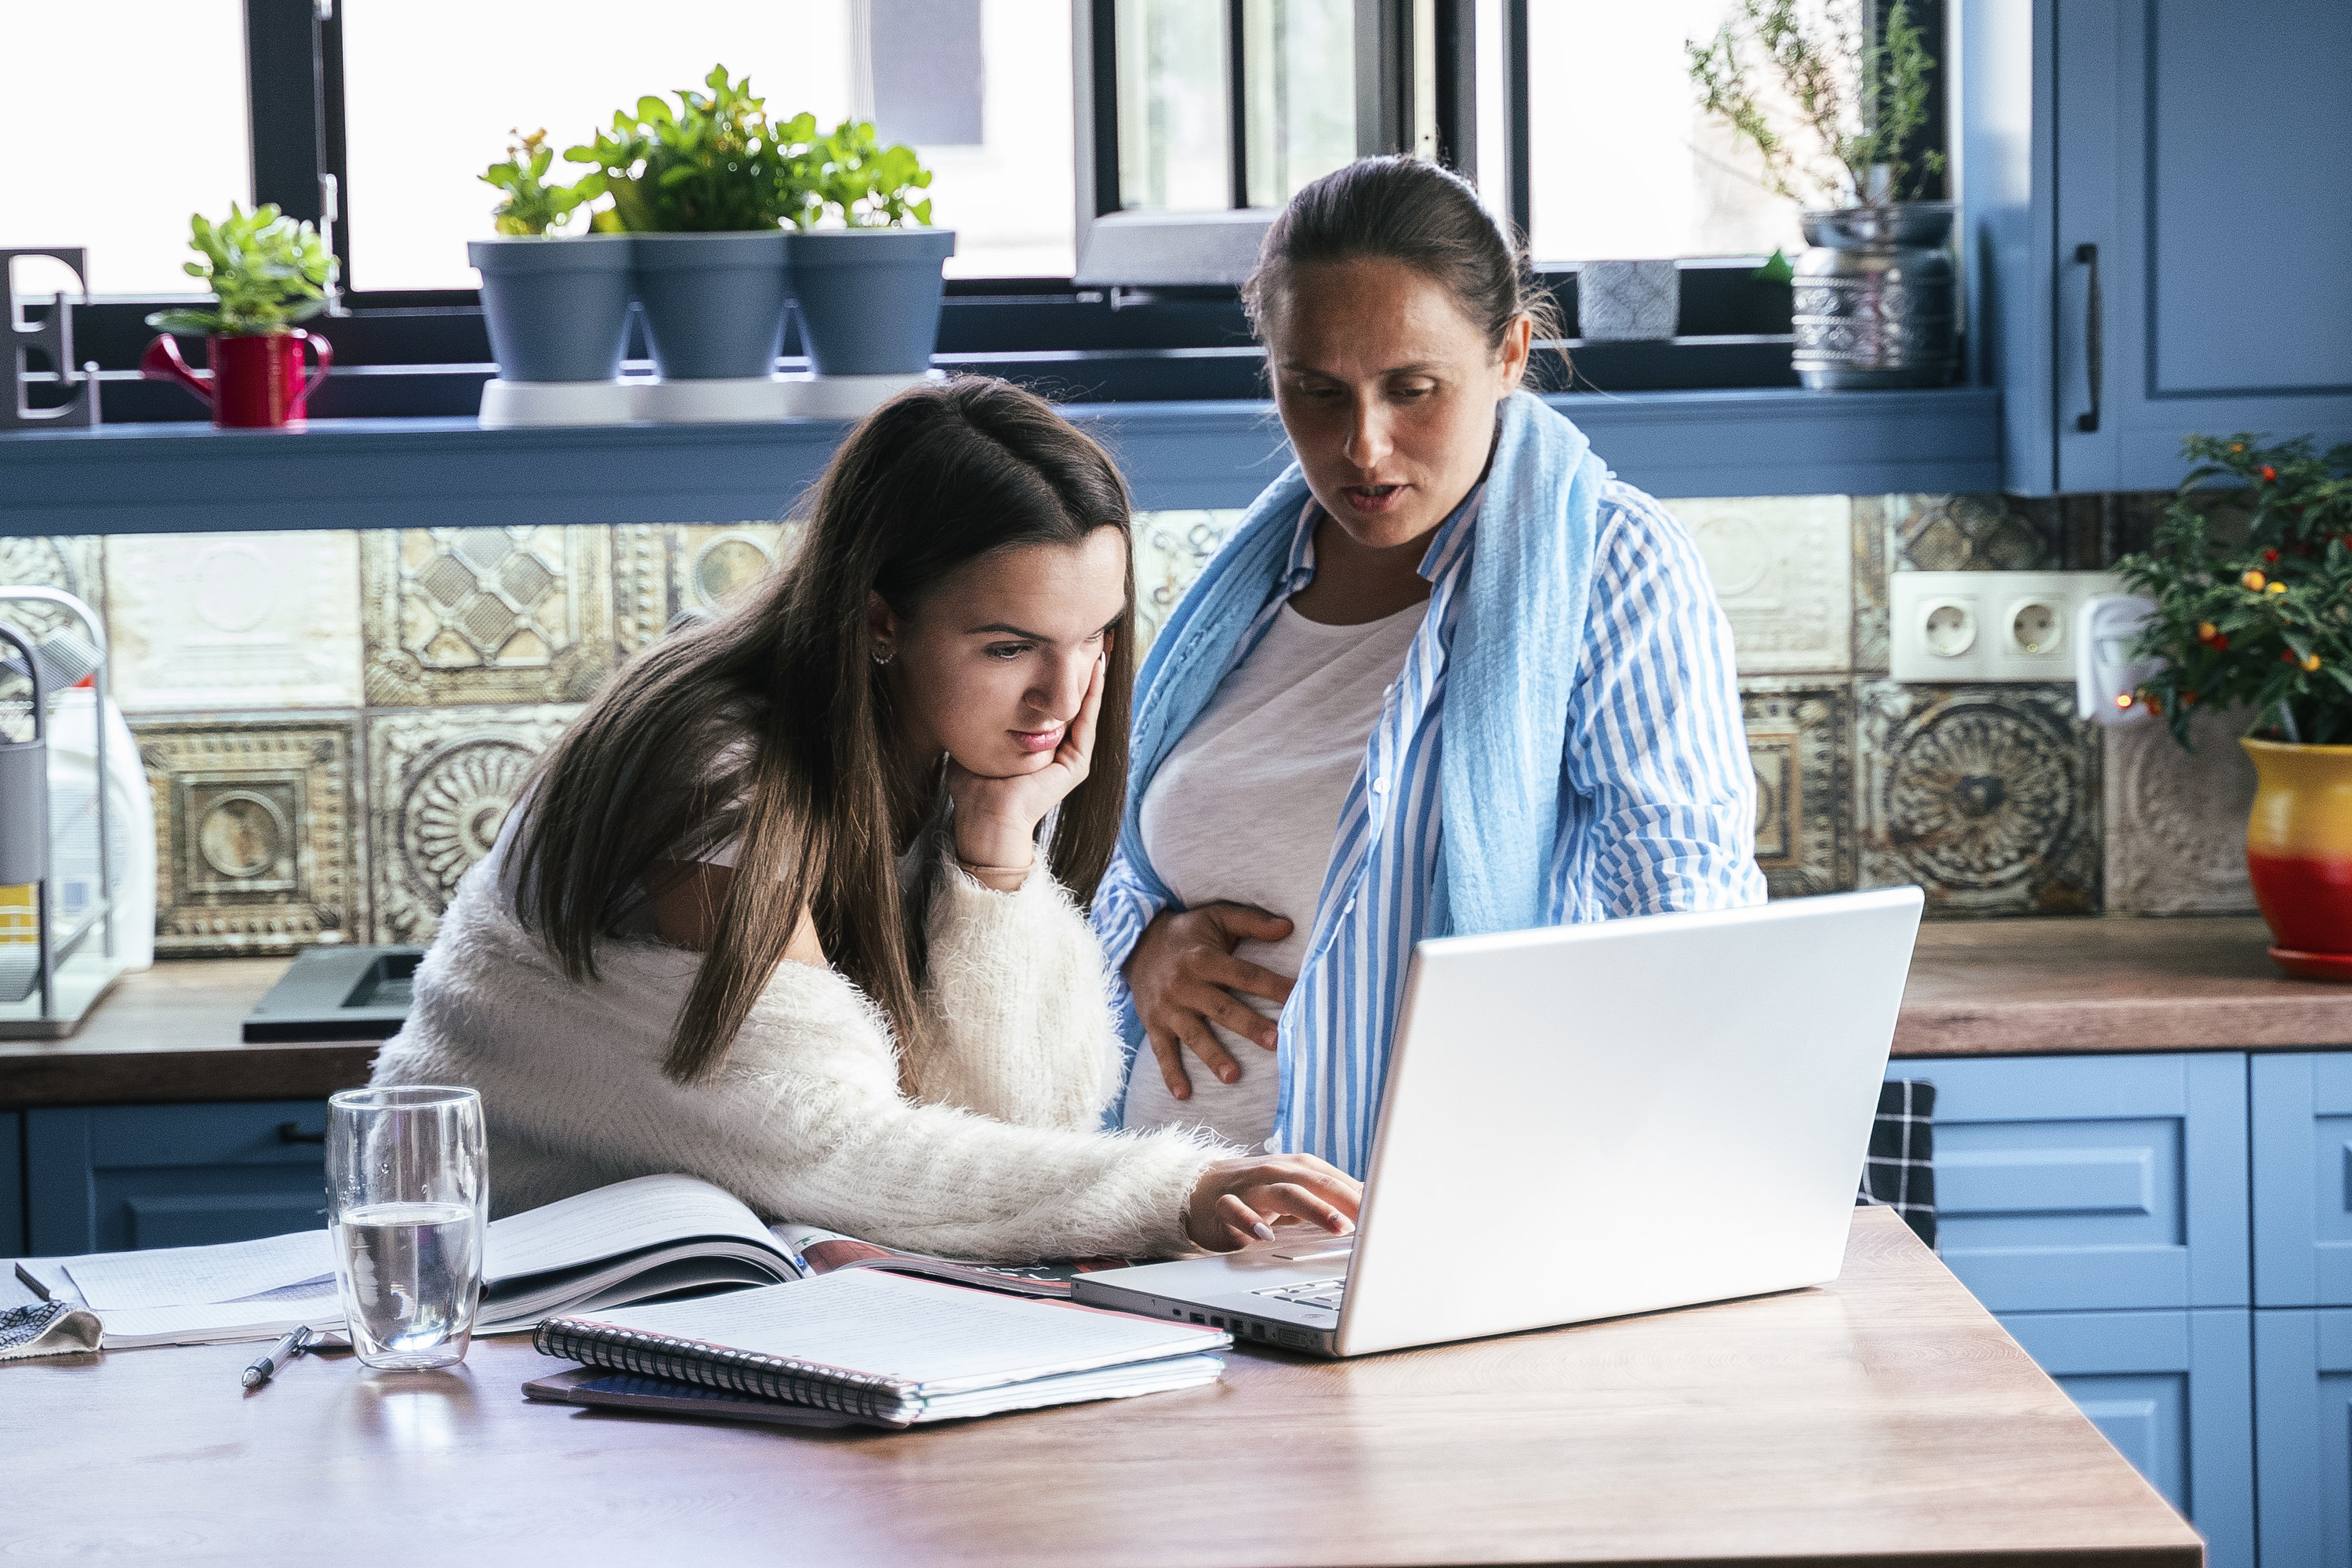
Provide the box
[1094,158,1764,1175]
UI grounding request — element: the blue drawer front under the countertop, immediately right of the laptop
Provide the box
[1889,1053,2249,1312]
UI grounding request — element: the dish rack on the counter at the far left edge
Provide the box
[0,588,125,1039]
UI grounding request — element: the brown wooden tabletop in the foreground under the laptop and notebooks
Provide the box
[0,1210,2201,1568]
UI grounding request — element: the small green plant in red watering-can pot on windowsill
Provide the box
[139,202,334,430]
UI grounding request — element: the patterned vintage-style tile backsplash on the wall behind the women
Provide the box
[0,496,2251,954]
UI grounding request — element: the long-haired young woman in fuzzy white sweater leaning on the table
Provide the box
[374,381,1355,1260]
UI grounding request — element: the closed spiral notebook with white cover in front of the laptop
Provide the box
[532,1269,1232,1427]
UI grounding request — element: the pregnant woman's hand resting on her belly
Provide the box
[1122,902,1291,1100]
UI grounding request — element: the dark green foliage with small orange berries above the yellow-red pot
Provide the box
[2114,435,2352,746]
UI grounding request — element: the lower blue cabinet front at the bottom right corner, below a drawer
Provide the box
[2253,1307,2352,1568]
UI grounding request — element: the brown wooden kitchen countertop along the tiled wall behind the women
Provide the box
[0,919,2352,1109]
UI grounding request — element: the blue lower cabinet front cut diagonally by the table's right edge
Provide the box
[2002,1307,2267,1568]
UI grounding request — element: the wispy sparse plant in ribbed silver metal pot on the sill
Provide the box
[1686,0,1959,388]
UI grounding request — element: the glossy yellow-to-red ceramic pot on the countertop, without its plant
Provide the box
[2239,741,2352,980]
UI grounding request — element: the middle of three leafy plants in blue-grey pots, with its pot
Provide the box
[564,66,800,392]
